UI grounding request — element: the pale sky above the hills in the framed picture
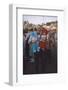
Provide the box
[23,15,57,24]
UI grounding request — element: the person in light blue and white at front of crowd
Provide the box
[28,29,39,62]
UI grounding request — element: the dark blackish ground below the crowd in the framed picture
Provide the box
[23,48,57,75]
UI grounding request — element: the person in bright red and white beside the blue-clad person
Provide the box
[39,29,47,73]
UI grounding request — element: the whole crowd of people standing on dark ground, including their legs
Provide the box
[23,27,57,71]
